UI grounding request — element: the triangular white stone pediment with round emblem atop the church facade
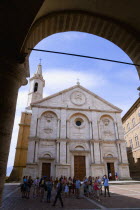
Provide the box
[31,85,122,112]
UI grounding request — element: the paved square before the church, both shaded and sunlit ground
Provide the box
[0,184,140,210]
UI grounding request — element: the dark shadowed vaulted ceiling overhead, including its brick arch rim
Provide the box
[0,0,140,77]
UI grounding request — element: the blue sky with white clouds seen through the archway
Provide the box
[7,32,139,175]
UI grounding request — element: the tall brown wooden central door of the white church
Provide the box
[74,156,86,181]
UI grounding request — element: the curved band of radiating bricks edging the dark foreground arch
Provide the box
[21,11,140,76]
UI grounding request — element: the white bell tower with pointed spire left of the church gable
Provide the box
[27,63,45,108]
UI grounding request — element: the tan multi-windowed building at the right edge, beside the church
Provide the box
[122,98,140,178]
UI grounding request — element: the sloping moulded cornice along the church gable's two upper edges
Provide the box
[31,84,122,112]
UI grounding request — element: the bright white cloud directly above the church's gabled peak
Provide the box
[43,69,107,96]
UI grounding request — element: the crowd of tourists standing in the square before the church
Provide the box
[21,175,114,207]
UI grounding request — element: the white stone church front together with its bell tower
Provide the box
[23,65,130,180]
